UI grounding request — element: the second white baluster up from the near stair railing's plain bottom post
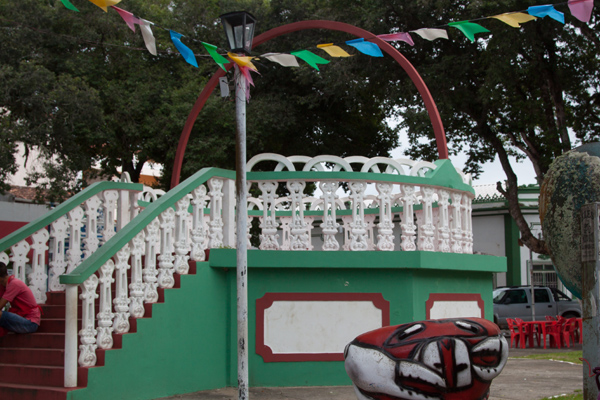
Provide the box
[97,260,115,349]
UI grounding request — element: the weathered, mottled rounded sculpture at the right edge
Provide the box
[540,143,600,298]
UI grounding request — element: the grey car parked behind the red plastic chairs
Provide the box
[493,286,581,328]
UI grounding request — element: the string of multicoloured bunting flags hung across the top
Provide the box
[61,0,594,75]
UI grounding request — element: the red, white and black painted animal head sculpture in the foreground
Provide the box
[344,318,508,400]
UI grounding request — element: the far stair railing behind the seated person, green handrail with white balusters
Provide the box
[0,181,144,304]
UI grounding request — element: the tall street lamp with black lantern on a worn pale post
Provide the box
[221,11,256,400]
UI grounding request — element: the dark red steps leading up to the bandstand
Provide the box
[0,262,196,400]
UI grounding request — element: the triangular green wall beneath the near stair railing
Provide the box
[68,263,235,400]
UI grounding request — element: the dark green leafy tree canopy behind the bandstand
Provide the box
[0,0,600,253]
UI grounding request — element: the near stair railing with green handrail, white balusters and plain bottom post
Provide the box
[60,168,235,387]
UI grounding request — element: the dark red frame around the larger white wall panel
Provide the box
[256,293,390,362]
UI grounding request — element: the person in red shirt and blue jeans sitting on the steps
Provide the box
[0,262,42,336]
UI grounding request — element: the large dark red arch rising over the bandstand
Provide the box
[171,20,448,187]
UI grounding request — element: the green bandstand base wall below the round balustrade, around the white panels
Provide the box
[210,250,506,387]
